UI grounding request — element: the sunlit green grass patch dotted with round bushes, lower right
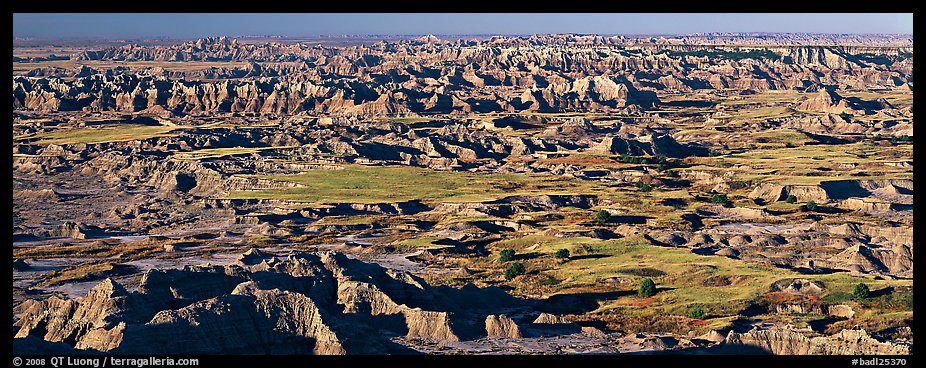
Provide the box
[493,235,912,318]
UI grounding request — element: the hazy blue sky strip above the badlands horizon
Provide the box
[13,13,913,38]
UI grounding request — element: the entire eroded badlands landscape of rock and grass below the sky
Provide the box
[12,34,914,355]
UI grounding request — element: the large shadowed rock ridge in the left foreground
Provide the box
[14,251,526,354]
